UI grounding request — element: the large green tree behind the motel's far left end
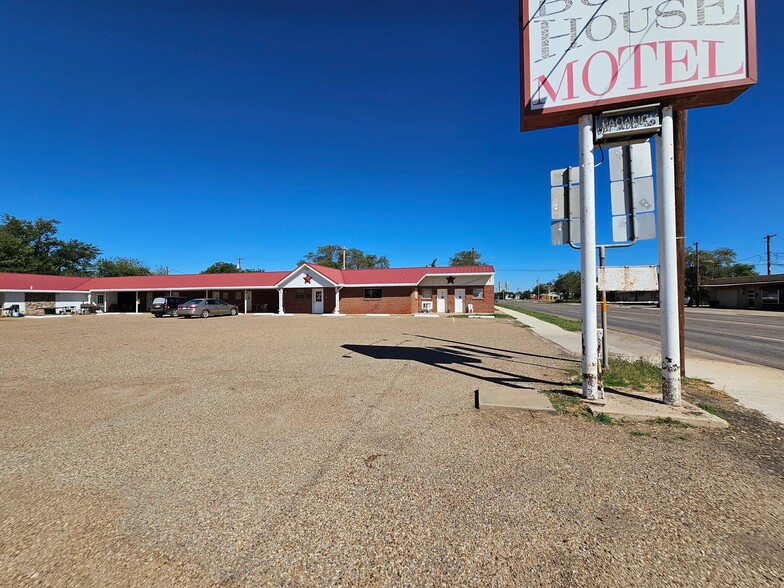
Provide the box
[0,214,101,275]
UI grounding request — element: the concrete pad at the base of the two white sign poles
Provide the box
[586,392,729,429]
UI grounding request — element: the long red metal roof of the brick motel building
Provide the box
[0,264,495,292]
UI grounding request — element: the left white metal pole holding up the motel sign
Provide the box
[579,114,599,400]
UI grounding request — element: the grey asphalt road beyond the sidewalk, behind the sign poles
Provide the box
[506,300,784,370]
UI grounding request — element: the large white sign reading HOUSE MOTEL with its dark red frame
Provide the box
[520,0,757,131]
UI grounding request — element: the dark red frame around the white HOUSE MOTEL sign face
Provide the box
[518,0,757,131]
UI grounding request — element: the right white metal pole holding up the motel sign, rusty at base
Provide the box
[656,106,681,406]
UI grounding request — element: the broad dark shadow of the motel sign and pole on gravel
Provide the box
[343,345,564,390]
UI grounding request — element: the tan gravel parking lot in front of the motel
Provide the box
[0,315,784,587]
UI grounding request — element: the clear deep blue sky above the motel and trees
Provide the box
[0,0,784,289]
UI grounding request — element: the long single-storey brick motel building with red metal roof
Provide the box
[0,263,495,316]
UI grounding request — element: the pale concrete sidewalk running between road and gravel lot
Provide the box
[496,306,784,423]
